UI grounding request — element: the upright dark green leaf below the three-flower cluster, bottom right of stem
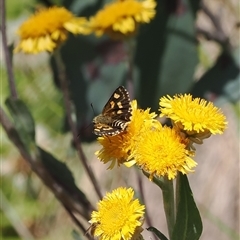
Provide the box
[172,174,202,240]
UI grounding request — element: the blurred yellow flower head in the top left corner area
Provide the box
[14,6,87,53]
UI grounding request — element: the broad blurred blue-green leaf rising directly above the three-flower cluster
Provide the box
[135,0,199,111]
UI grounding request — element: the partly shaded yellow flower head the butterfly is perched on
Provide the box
[96,100,157,169]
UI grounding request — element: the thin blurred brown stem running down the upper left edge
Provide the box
[0,0,18,99]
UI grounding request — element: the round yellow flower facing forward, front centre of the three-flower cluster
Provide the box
[131,123,197,180]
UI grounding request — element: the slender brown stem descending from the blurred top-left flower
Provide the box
[55,48,102,199]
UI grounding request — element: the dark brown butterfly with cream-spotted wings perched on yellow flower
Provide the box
[93,86,132,136]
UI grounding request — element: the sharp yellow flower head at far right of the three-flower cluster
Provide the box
[159,94,227,138]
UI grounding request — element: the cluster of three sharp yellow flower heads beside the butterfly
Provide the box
[96,94,227,180]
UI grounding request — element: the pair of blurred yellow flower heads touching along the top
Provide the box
[15,0,156,54]
